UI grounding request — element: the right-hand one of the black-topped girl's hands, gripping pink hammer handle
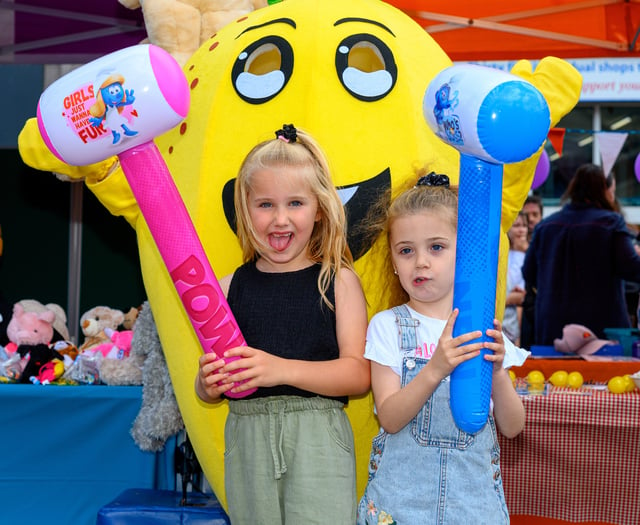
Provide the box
[223,346,288,393]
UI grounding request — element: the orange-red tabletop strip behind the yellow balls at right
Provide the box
[511,356,640,383]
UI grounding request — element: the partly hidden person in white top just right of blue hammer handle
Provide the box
[502,211,529,346]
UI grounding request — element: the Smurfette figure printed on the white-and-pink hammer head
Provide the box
[89,73,138,144]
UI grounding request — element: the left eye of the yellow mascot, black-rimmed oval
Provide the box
[231,36,293,104]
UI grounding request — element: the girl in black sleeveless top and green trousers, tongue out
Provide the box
[195,126,370,525]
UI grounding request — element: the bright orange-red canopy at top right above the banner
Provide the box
[388,0,640,61]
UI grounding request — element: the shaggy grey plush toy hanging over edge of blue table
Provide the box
[100,301,184,452]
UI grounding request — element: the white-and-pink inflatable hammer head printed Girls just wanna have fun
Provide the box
[38,45,190,166]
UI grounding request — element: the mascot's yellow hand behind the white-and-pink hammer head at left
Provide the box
[18,118,118,183]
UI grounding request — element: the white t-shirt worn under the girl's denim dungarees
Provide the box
[364,305,531,376]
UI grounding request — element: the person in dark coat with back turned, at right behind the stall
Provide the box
[522,164,640,346]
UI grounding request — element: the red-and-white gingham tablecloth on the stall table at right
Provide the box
[499,387,640,525]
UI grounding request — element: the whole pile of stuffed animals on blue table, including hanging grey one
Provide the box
[0,299,184,452]
